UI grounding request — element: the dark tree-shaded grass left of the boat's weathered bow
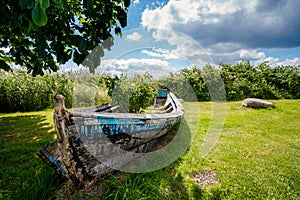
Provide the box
[0,115,59,199]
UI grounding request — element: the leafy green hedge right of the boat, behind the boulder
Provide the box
[176,61,300,101]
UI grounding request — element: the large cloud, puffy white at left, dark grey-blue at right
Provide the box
[141,0,300,47]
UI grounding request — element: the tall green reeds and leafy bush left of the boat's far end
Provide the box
[0,71,157,113]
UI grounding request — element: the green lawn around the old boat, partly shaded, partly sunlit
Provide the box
[0,100,300,199]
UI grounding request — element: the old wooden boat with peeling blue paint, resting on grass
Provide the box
[37,90,184,190]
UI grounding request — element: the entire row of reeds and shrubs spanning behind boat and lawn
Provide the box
[0,61,300,112]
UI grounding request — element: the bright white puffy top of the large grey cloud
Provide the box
[141,0,243,28]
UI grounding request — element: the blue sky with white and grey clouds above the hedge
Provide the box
[70,0,300,74]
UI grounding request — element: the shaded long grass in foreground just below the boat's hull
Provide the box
[94,159,224,200]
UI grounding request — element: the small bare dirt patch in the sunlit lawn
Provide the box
[192,170,218,188]
